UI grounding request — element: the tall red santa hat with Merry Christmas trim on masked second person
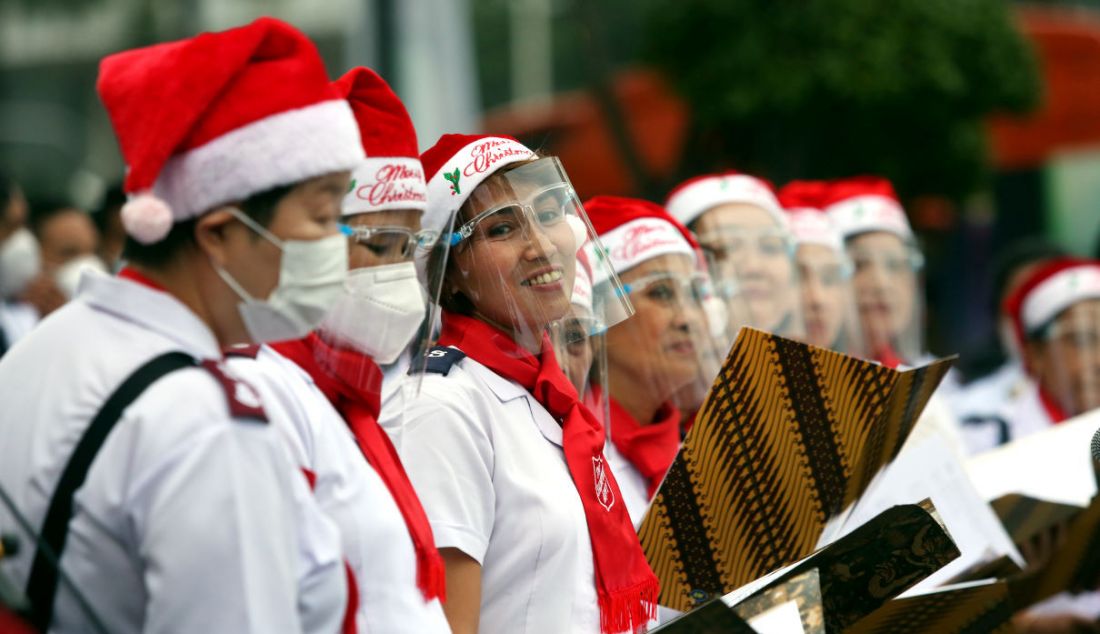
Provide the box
[333,66,428,216]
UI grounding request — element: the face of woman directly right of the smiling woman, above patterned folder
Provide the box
[606,254,707,401]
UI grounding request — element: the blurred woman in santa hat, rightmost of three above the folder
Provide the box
[821,176,928,367]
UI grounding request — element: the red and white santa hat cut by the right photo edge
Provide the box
[1001,258,1100,346]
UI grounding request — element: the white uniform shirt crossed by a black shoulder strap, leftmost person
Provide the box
[0,275,347,634]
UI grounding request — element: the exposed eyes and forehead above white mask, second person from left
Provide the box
[344,209,421,270]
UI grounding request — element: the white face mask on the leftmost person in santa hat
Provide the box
[213,209,348,343]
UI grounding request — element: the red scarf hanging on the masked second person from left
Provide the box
[272,334,447,601]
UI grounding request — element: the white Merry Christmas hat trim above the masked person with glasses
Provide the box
[341,156,428,216]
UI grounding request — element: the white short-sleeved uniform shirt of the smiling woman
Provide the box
[383,359,600,634]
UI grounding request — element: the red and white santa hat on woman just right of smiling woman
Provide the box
[584,196,699,276]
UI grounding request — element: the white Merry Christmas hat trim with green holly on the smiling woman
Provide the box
[420,136,536,231]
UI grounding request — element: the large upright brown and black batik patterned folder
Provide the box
[639,328,952,610]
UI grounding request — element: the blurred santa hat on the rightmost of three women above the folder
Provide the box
[822,176,913,241]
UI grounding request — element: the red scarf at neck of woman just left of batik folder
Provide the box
[611,396,680,500]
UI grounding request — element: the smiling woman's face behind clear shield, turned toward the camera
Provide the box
[446,177,579,337]
